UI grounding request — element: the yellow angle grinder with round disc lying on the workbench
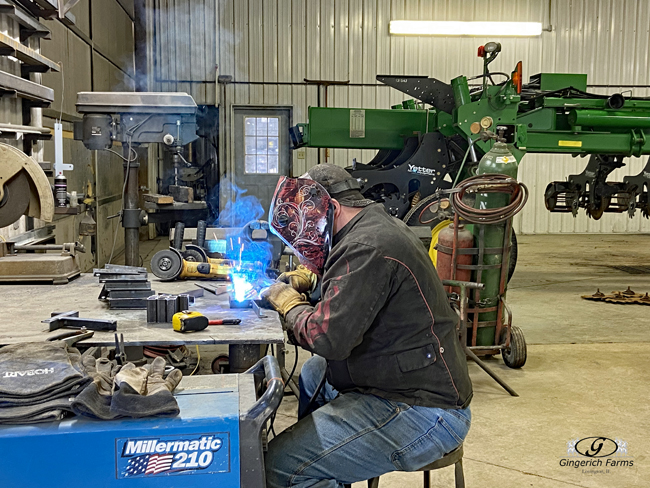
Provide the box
[151,248,232,281]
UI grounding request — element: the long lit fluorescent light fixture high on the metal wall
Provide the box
[389,20,542,37]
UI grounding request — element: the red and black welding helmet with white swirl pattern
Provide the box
[269,176,334,275]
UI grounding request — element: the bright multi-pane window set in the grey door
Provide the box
[244,117,280,175]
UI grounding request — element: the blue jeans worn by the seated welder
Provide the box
[266,356,471,488]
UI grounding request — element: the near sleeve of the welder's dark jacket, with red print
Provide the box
[286,241,393,361]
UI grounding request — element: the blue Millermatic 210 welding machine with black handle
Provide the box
[0,356,284,488]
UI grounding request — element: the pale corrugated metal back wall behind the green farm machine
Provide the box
[147,0,650,233]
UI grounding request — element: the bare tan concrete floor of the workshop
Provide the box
[133,235,650,488]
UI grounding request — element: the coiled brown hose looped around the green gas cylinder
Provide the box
[450,174,528,224]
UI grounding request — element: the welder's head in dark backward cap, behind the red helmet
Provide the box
[305,163,375,234]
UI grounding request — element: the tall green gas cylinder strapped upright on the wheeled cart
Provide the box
[472,142,519,346]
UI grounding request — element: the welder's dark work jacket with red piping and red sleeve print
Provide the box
[286,204,472,408]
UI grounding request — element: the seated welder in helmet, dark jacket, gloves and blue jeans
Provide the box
[262,164,472,488]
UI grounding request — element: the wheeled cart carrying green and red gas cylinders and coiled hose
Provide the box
[421,166,528,395]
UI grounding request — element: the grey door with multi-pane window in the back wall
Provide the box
[233,107,291,220]
